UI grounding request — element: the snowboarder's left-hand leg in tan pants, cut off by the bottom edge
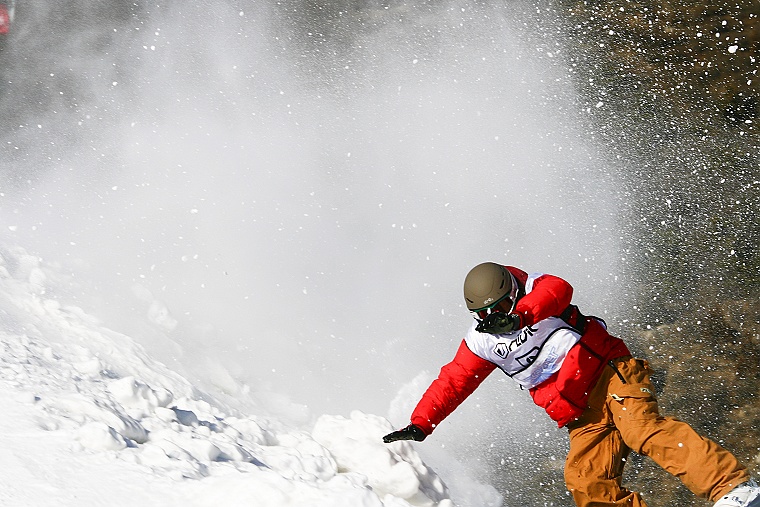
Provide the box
[565,367,646,507]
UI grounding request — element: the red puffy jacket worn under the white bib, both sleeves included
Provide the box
[411,266,630,434]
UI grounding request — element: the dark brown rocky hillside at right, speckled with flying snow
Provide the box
[558,0,760,506]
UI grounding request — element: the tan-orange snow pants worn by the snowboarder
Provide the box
[565,357,749,507]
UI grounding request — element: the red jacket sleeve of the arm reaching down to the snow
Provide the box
[411,340,496,435]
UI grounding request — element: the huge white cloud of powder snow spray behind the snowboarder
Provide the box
[0,2,616,436]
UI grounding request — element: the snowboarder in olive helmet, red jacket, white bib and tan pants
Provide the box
[383,262,760,507]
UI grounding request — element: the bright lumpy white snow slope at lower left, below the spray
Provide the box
[0,247,501,507]
